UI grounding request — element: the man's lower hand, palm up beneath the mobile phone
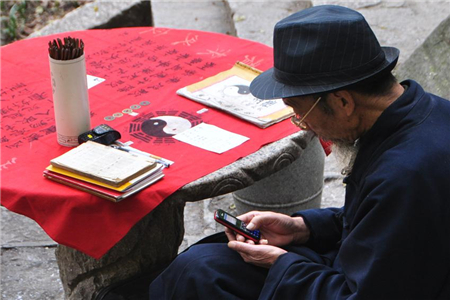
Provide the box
[228,241,287,268]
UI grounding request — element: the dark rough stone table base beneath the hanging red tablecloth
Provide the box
[55,199,184,300]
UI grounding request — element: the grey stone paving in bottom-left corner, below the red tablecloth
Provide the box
[0,207,64,300]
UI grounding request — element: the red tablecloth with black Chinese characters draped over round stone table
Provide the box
[1,28,296,258]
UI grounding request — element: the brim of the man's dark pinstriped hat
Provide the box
[250,47,400,100]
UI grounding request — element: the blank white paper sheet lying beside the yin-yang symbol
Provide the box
[173,123,249,154]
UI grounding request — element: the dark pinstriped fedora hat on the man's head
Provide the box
[250,5,400,99]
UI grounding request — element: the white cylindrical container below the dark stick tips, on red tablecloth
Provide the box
[49,54,91,147]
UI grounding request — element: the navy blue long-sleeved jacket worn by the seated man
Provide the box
[261,81,450,300]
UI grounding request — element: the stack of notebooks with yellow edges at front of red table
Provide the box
[44,141,164,202]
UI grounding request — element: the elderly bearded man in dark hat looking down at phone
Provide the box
[150,6,450,299]
